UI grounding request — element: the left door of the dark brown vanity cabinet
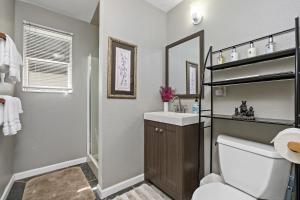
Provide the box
[144,121,162,186]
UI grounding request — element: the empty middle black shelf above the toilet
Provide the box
[204,72,295,86]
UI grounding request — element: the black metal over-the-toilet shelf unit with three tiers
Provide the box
[199,17,300,200]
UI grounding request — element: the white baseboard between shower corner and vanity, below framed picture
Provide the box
[97,174,145,199]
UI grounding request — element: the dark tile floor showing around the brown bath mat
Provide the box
[6,163,100,200]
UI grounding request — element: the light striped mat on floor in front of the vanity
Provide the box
[114,184,165,200]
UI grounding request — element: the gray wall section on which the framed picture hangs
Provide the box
[99,0,167,188]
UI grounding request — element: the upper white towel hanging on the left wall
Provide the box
[0,35,23,81]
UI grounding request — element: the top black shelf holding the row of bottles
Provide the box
[207,48,295,71]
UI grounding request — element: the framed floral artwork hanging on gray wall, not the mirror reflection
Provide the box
[107,37,137,99]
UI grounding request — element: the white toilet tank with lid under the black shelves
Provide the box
[217,135,291,200]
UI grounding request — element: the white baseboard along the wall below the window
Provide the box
[14,157,87,181]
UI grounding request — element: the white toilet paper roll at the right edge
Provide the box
[271,128,300,164]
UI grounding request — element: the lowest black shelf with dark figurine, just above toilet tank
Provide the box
[201,114,294,126]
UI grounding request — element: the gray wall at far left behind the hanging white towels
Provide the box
[0,0,15,197]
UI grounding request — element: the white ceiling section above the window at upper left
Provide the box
[19,0,99,23]
